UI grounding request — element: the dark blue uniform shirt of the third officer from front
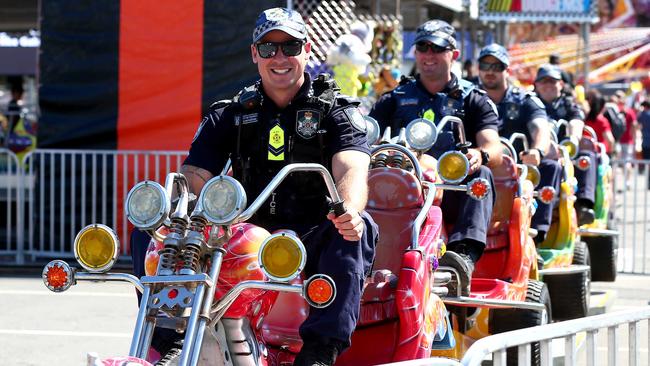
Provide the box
[497,86,547,141]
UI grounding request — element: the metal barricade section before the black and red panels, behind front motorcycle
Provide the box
[23,149,187,260]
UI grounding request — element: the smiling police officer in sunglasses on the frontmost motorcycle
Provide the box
[132,8,378,365]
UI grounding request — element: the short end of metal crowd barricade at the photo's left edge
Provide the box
[0,148,24,264]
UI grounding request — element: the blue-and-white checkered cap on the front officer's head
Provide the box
[253,8,307,43]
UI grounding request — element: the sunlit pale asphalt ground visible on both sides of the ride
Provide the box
[0,274,650,366]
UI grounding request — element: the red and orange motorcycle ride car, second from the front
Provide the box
[426,117,555,364]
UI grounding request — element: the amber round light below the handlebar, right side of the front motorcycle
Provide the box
[258,232,307,282]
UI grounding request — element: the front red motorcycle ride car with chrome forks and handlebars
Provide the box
[43,138,453,365]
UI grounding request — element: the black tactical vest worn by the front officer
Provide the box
[224,75,342,231]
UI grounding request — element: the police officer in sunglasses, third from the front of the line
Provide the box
[478,43,562,243]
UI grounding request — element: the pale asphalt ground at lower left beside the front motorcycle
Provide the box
[0,275,138,366]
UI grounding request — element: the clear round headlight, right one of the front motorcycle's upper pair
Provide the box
[199,175,246,225]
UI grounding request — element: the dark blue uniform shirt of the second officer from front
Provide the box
[369,74,498,158]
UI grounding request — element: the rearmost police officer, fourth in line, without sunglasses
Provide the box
[535,65,598,226]
